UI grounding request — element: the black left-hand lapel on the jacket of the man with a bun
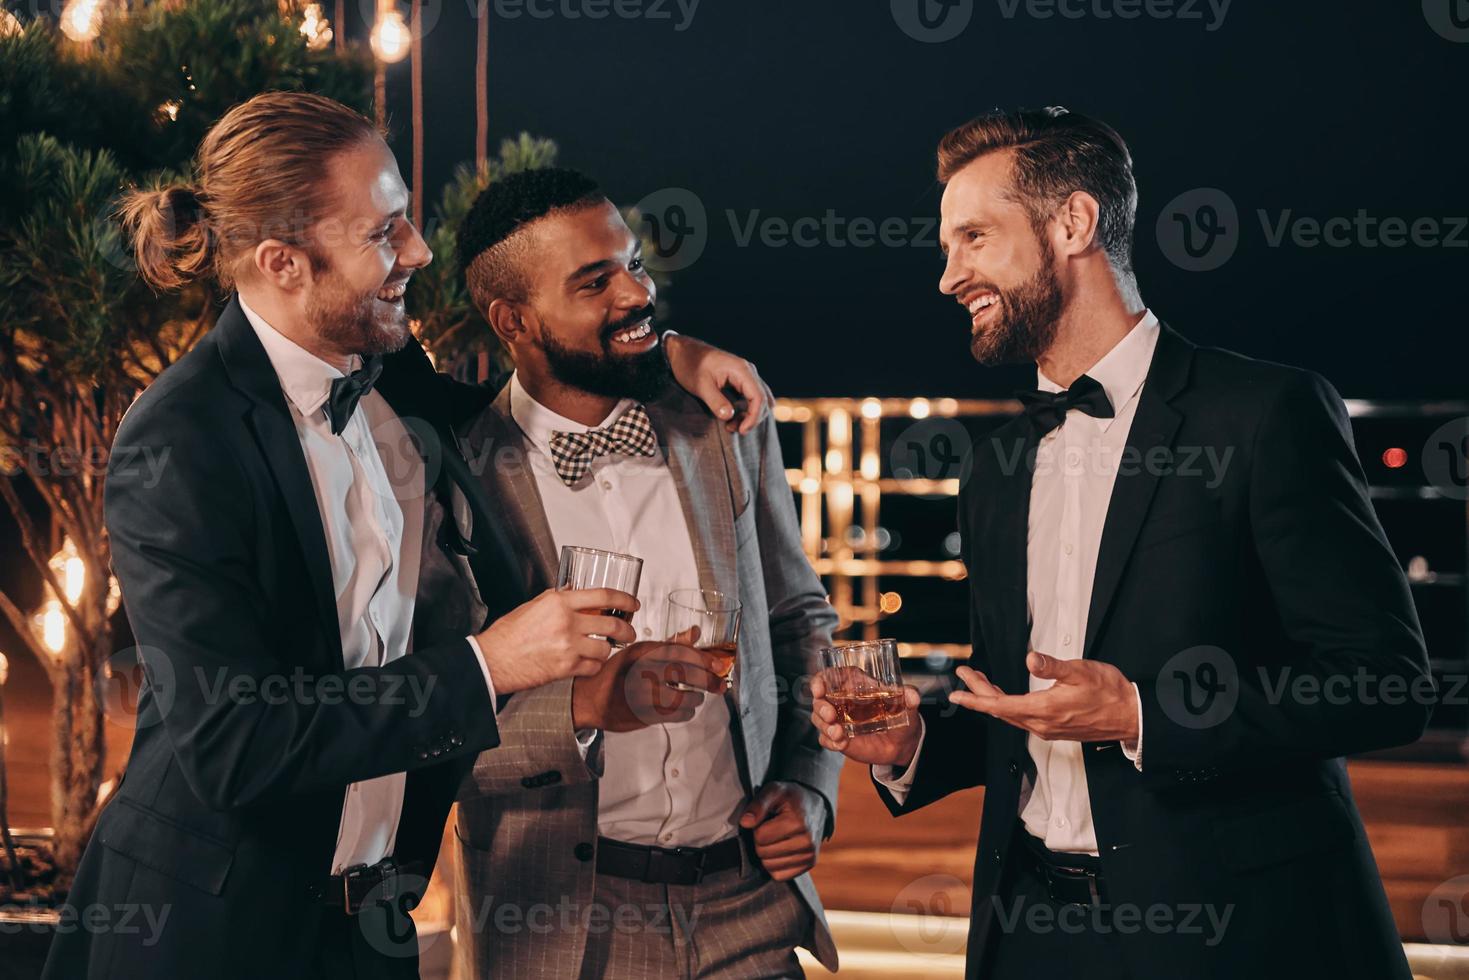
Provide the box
[214,298,342,670]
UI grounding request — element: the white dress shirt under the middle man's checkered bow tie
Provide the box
[510,376,746,848]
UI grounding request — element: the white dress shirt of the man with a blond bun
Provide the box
[239,298,495,874]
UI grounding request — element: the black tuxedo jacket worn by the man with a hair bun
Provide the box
[47,301,523,980]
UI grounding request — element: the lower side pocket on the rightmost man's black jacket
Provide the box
[1215,792,1357,871]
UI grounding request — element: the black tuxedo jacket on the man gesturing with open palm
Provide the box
[878,326,1431,980]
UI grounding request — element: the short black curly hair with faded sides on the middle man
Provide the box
[455,167,607,311]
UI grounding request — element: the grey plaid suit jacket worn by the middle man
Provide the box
[455,386,842,980]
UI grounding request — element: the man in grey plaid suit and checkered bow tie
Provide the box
[455,169,842,980]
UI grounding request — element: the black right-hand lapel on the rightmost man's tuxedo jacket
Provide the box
[1083,323,1193,657]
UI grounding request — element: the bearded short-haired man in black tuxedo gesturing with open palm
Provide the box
[812,107,1432,980]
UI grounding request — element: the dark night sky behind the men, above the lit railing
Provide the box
[370,0,1469,398]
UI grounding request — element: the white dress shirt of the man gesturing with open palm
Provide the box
[873,310,1159,855]
